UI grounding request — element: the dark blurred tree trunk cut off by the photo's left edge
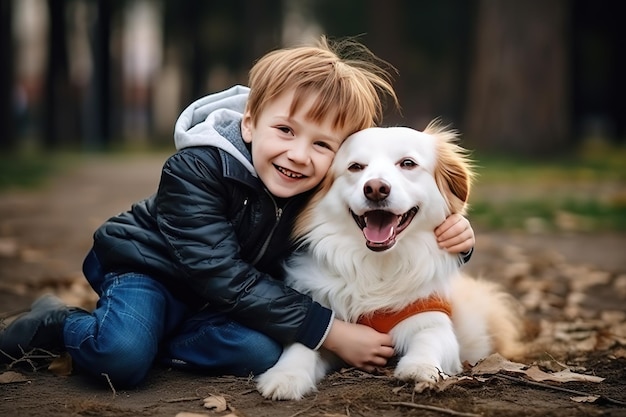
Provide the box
[0,0,15,151]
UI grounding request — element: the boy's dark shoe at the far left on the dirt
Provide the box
[0,294,75,362]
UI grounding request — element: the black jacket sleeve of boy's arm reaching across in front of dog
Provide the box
[156,150,333,348]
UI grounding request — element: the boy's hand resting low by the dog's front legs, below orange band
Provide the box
[322,319,394,372]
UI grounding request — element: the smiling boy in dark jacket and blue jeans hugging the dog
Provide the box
[0,39,474,387]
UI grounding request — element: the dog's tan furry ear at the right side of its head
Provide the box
[424,121,474,214]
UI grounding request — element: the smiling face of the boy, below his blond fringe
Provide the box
[241,91,349,198]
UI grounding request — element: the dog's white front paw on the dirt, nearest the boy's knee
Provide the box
[257,368,317,400]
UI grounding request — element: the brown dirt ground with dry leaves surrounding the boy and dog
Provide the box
[0,155,626,417]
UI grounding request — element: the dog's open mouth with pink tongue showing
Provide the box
[350,207,419,252]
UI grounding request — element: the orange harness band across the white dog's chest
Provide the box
[357,295,452,333]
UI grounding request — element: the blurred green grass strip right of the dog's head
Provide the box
[469,148,626,232]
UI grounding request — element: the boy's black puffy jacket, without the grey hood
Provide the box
[94,98,332,348]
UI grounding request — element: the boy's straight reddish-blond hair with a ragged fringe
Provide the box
[246,37,399,133]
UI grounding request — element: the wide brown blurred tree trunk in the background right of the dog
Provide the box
[465,0,570,156]
